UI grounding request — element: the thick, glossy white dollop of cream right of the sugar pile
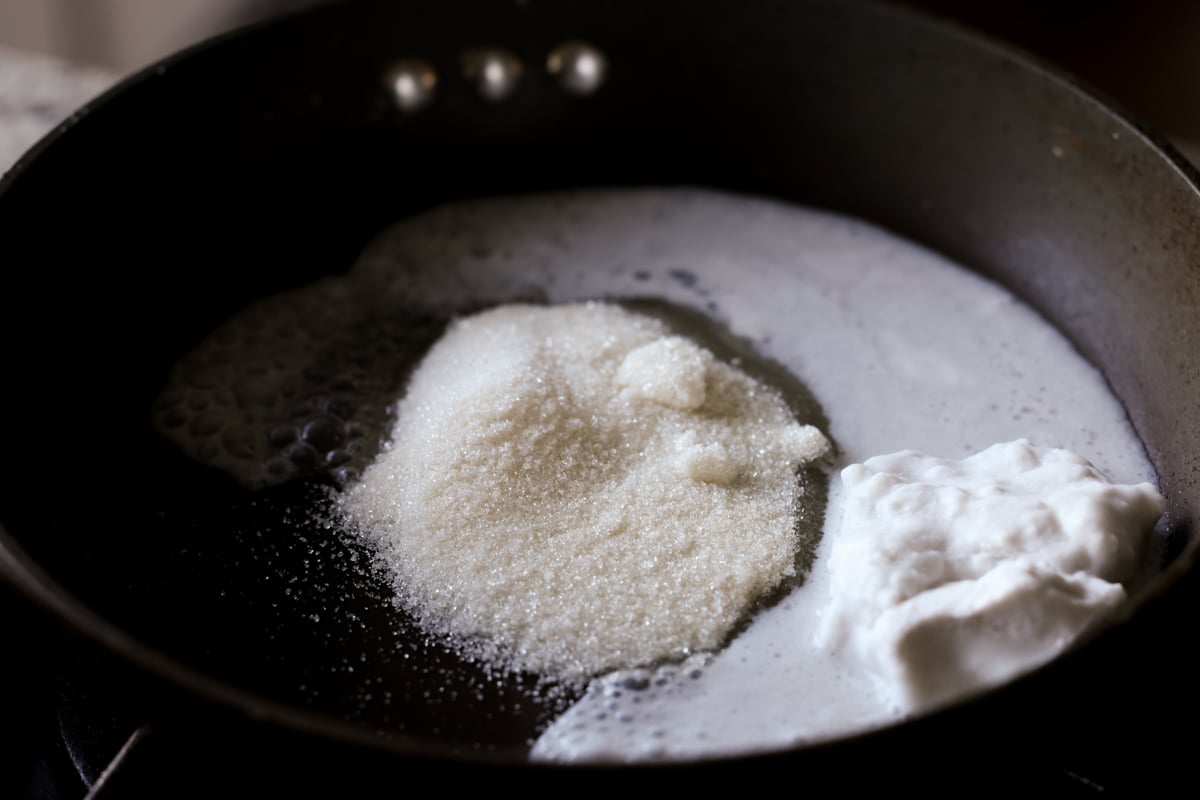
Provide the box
[817,439,1164,710]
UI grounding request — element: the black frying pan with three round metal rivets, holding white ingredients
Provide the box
[0,0,1200,782]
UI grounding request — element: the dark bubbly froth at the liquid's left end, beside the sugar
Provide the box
[154,279,442,488]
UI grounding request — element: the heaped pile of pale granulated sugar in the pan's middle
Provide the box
[333,302,829,680]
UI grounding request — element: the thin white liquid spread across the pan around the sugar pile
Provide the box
[154,190,1154,762]
